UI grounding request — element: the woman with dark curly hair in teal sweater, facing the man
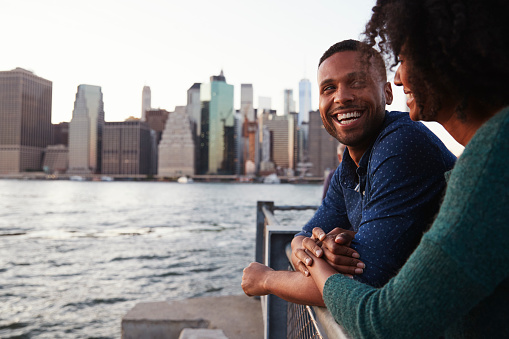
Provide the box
[302,0,509,338]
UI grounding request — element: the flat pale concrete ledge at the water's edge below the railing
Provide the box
[121,295,263,339]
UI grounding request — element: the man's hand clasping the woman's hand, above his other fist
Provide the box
[292,227,365,276]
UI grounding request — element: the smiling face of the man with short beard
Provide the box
[318,51,392,148]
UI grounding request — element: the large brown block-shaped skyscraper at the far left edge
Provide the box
[0,68,52,173]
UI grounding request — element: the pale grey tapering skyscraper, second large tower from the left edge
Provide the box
[67,85,104,174]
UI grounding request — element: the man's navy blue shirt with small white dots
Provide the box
[298,112,456,287]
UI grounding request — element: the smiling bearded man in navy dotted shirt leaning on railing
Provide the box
[242,40,455,305]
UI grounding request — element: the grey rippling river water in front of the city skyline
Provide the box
[0,180,322,338]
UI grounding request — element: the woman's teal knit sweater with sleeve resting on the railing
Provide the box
[323,111,509,338]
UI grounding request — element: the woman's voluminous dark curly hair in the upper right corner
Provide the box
[364,0,509,120]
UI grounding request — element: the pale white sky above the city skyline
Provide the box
[0,0,462,154]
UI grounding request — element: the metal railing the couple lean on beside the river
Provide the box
[256,201,348,339]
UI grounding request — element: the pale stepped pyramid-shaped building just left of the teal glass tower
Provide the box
[157,106,195,177]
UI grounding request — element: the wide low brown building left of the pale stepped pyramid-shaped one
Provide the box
[102,120,154,176]
